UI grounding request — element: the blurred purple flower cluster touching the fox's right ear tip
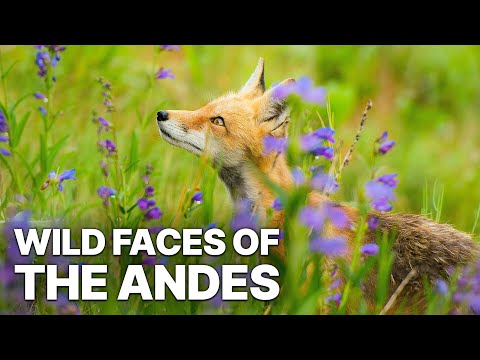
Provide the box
[273,76,326,105]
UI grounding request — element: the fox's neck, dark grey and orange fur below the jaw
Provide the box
[219,154,293,212]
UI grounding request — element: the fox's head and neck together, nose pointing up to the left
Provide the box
[157,58,295,209]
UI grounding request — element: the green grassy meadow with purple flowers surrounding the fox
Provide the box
[0,45,480,314]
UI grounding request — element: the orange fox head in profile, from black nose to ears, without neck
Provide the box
[157,58,294,167]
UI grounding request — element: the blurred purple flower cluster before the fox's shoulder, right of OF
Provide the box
[299,202,352,256]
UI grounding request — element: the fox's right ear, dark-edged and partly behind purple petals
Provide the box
[259,79,295,137]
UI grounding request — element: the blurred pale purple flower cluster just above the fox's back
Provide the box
[365,174,398,212]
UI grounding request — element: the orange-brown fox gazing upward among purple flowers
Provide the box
[157,58,480,310]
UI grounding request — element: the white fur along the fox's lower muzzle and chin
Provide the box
[158,119,205,155]
